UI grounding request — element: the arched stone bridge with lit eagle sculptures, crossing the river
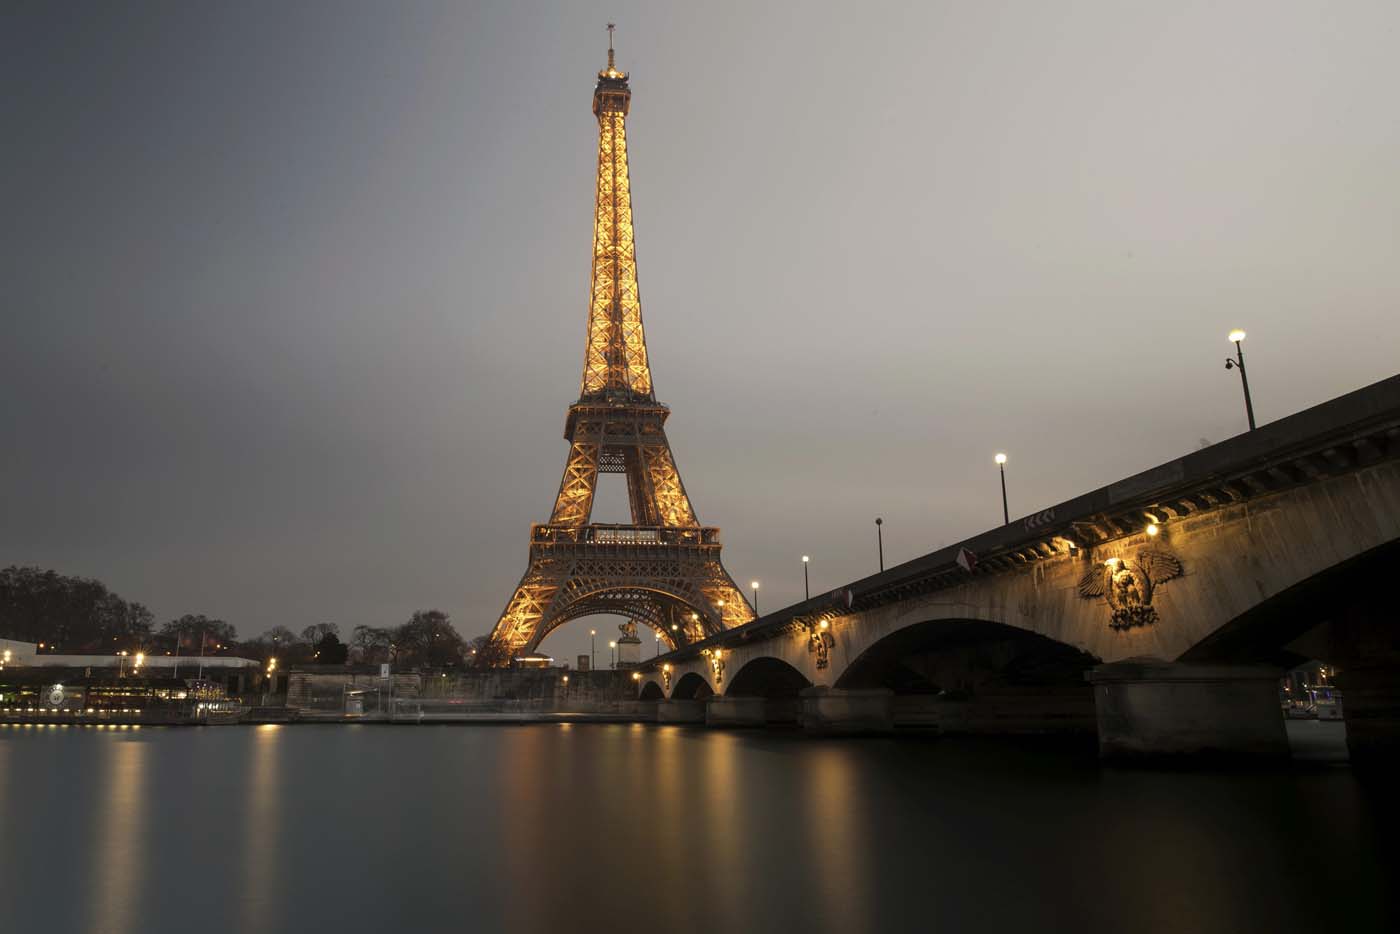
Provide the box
[637,375,1400,760]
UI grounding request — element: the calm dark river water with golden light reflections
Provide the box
[0,724,1400,934]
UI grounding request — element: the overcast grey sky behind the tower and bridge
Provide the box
[0,0,1400,655]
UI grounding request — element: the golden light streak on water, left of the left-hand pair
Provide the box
[88,737,150,934]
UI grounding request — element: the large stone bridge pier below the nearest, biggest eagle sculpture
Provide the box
[1085,660,1289,759]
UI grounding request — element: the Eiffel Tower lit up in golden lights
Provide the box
[479,32,753,665]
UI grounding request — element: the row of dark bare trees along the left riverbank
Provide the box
[0,566,484,668]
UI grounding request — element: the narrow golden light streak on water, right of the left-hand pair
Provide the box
[239,724,286,931]
